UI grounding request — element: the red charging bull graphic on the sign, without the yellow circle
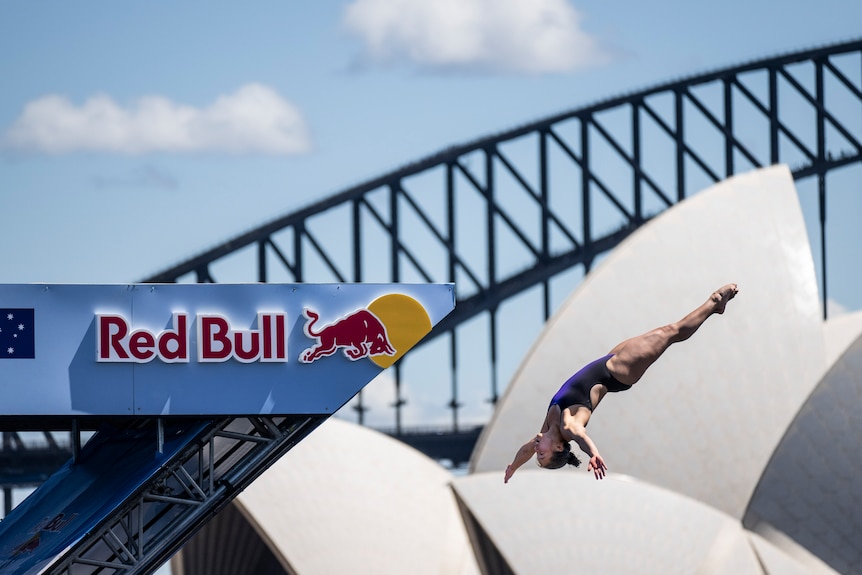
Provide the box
[299,308,395,363]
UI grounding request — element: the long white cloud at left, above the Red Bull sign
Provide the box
[0,84,311,154]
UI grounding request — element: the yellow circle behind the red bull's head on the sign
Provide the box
[368,294,432,369]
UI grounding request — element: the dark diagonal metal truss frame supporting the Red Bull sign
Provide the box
[45,416,326,575]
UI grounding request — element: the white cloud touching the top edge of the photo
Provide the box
[344,0,608,74]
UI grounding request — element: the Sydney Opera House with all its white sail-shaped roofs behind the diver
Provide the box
[172,166,862,575]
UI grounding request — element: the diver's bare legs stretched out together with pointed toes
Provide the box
[607,284,739,385]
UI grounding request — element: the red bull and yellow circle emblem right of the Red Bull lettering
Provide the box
[299,294,431,368]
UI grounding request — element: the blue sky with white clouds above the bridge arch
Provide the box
[0,0,862,283]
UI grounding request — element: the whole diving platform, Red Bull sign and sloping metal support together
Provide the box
[0,284,454,575]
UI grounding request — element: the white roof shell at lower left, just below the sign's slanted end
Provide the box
[234,418,479,575]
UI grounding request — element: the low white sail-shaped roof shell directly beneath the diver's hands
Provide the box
[454,469,834,575]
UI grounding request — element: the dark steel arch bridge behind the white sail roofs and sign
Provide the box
[0,39,862,568]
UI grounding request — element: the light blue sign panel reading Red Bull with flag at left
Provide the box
[0,284,454,417]
